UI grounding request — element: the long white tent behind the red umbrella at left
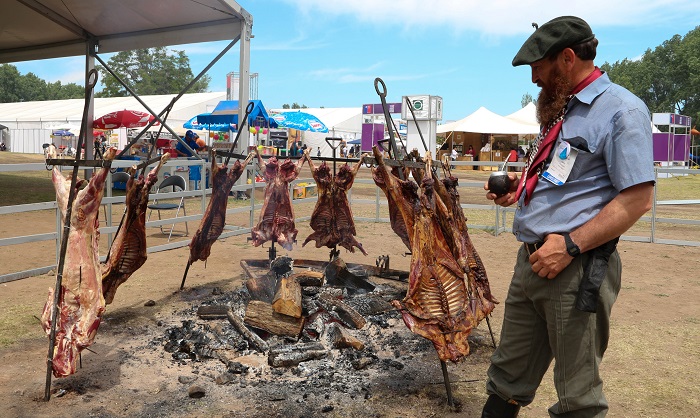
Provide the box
[0,92,226,154]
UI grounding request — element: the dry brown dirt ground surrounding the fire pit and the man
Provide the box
[0,159,700,417]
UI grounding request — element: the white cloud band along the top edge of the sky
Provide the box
[283,0,700,38]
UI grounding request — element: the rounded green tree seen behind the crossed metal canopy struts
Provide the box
[96,47,211,97]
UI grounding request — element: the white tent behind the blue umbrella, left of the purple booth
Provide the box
[270,107,362,157]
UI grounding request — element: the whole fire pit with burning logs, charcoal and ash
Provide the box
[153,257,490,416]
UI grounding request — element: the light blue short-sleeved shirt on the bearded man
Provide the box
[513,74,655,243]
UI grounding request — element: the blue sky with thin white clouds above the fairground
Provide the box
[13,0,700,123]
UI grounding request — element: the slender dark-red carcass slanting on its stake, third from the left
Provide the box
[189,152,255,264]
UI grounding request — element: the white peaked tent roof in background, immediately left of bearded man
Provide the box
[437,106,539,135]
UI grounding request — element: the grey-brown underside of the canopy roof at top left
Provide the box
[0,0,252,63]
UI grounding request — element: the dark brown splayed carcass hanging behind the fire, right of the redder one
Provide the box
[302,152,367,255]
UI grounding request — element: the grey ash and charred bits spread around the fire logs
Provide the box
[151,262,485,417]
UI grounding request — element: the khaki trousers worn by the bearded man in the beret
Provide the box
[486,243,622,418]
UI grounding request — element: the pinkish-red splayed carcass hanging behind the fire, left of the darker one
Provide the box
[251,150,309,251]
